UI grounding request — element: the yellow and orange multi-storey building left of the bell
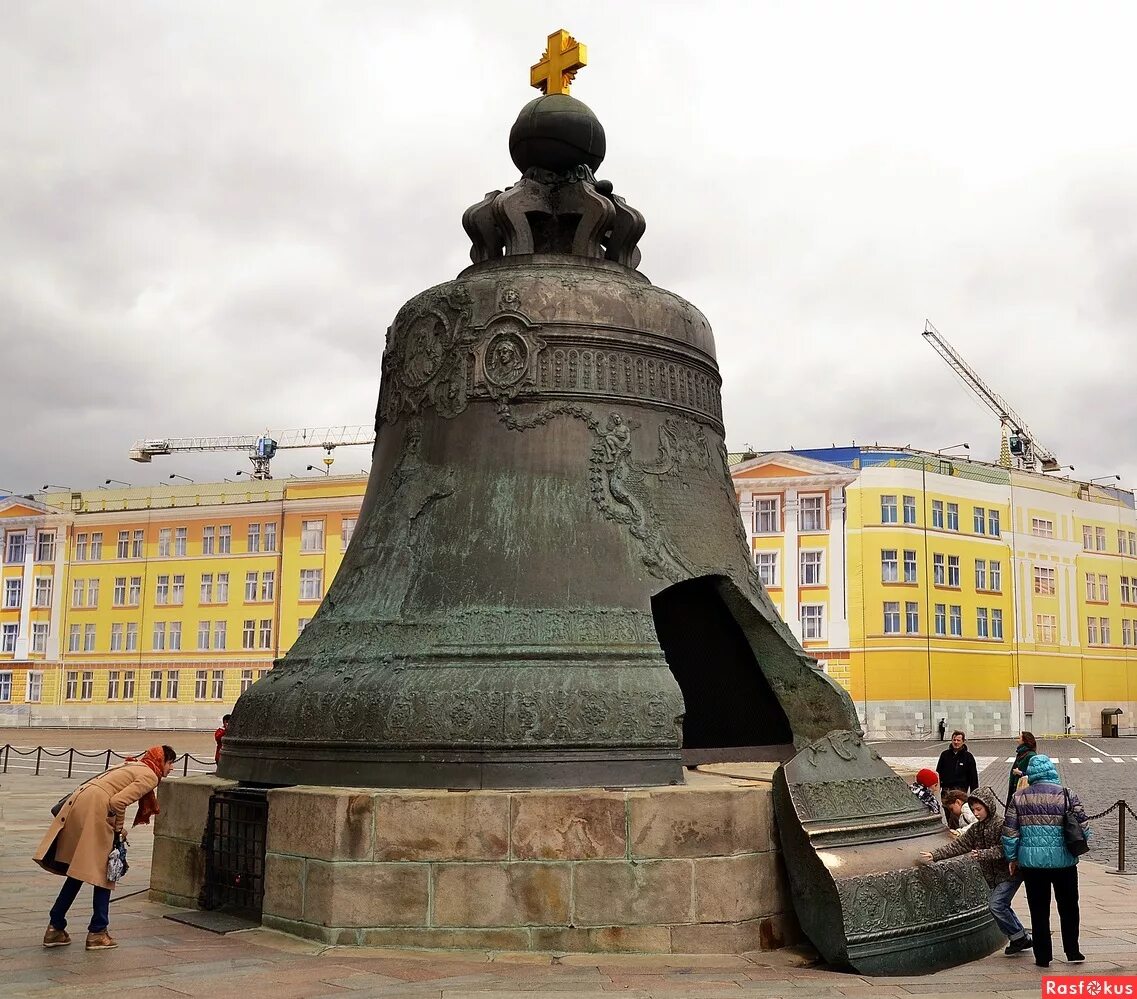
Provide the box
[0,475,366,727]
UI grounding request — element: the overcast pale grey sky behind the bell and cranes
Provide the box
[0,0,1137,492]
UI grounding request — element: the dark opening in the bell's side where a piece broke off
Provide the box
[652,576,794,766]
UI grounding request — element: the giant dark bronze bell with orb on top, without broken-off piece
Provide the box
[221,93,856,788]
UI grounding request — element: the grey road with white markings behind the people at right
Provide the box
[873,736,1137,871]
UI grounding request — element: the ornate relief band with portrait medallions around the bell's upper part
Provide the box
[379,285,722,431]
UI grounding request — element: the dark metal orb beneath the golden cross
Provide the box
[509,93,606,174]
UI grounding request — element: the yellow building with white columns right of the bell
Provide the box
[732,448,1137,738]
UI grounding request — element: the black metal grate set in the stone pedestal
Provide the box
[201,788,268,919]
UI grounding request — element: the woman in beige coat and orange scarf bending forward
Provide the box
[32,746,177,950]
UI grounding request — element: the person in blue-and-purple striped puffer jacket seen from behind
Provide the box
[1003,754,1089,968]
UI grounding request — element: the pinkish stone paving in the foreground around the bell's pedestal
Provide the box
[0,774,1137,999]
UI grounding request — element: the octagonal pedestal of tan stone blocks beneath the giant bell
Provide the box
[150,765,799,954]
